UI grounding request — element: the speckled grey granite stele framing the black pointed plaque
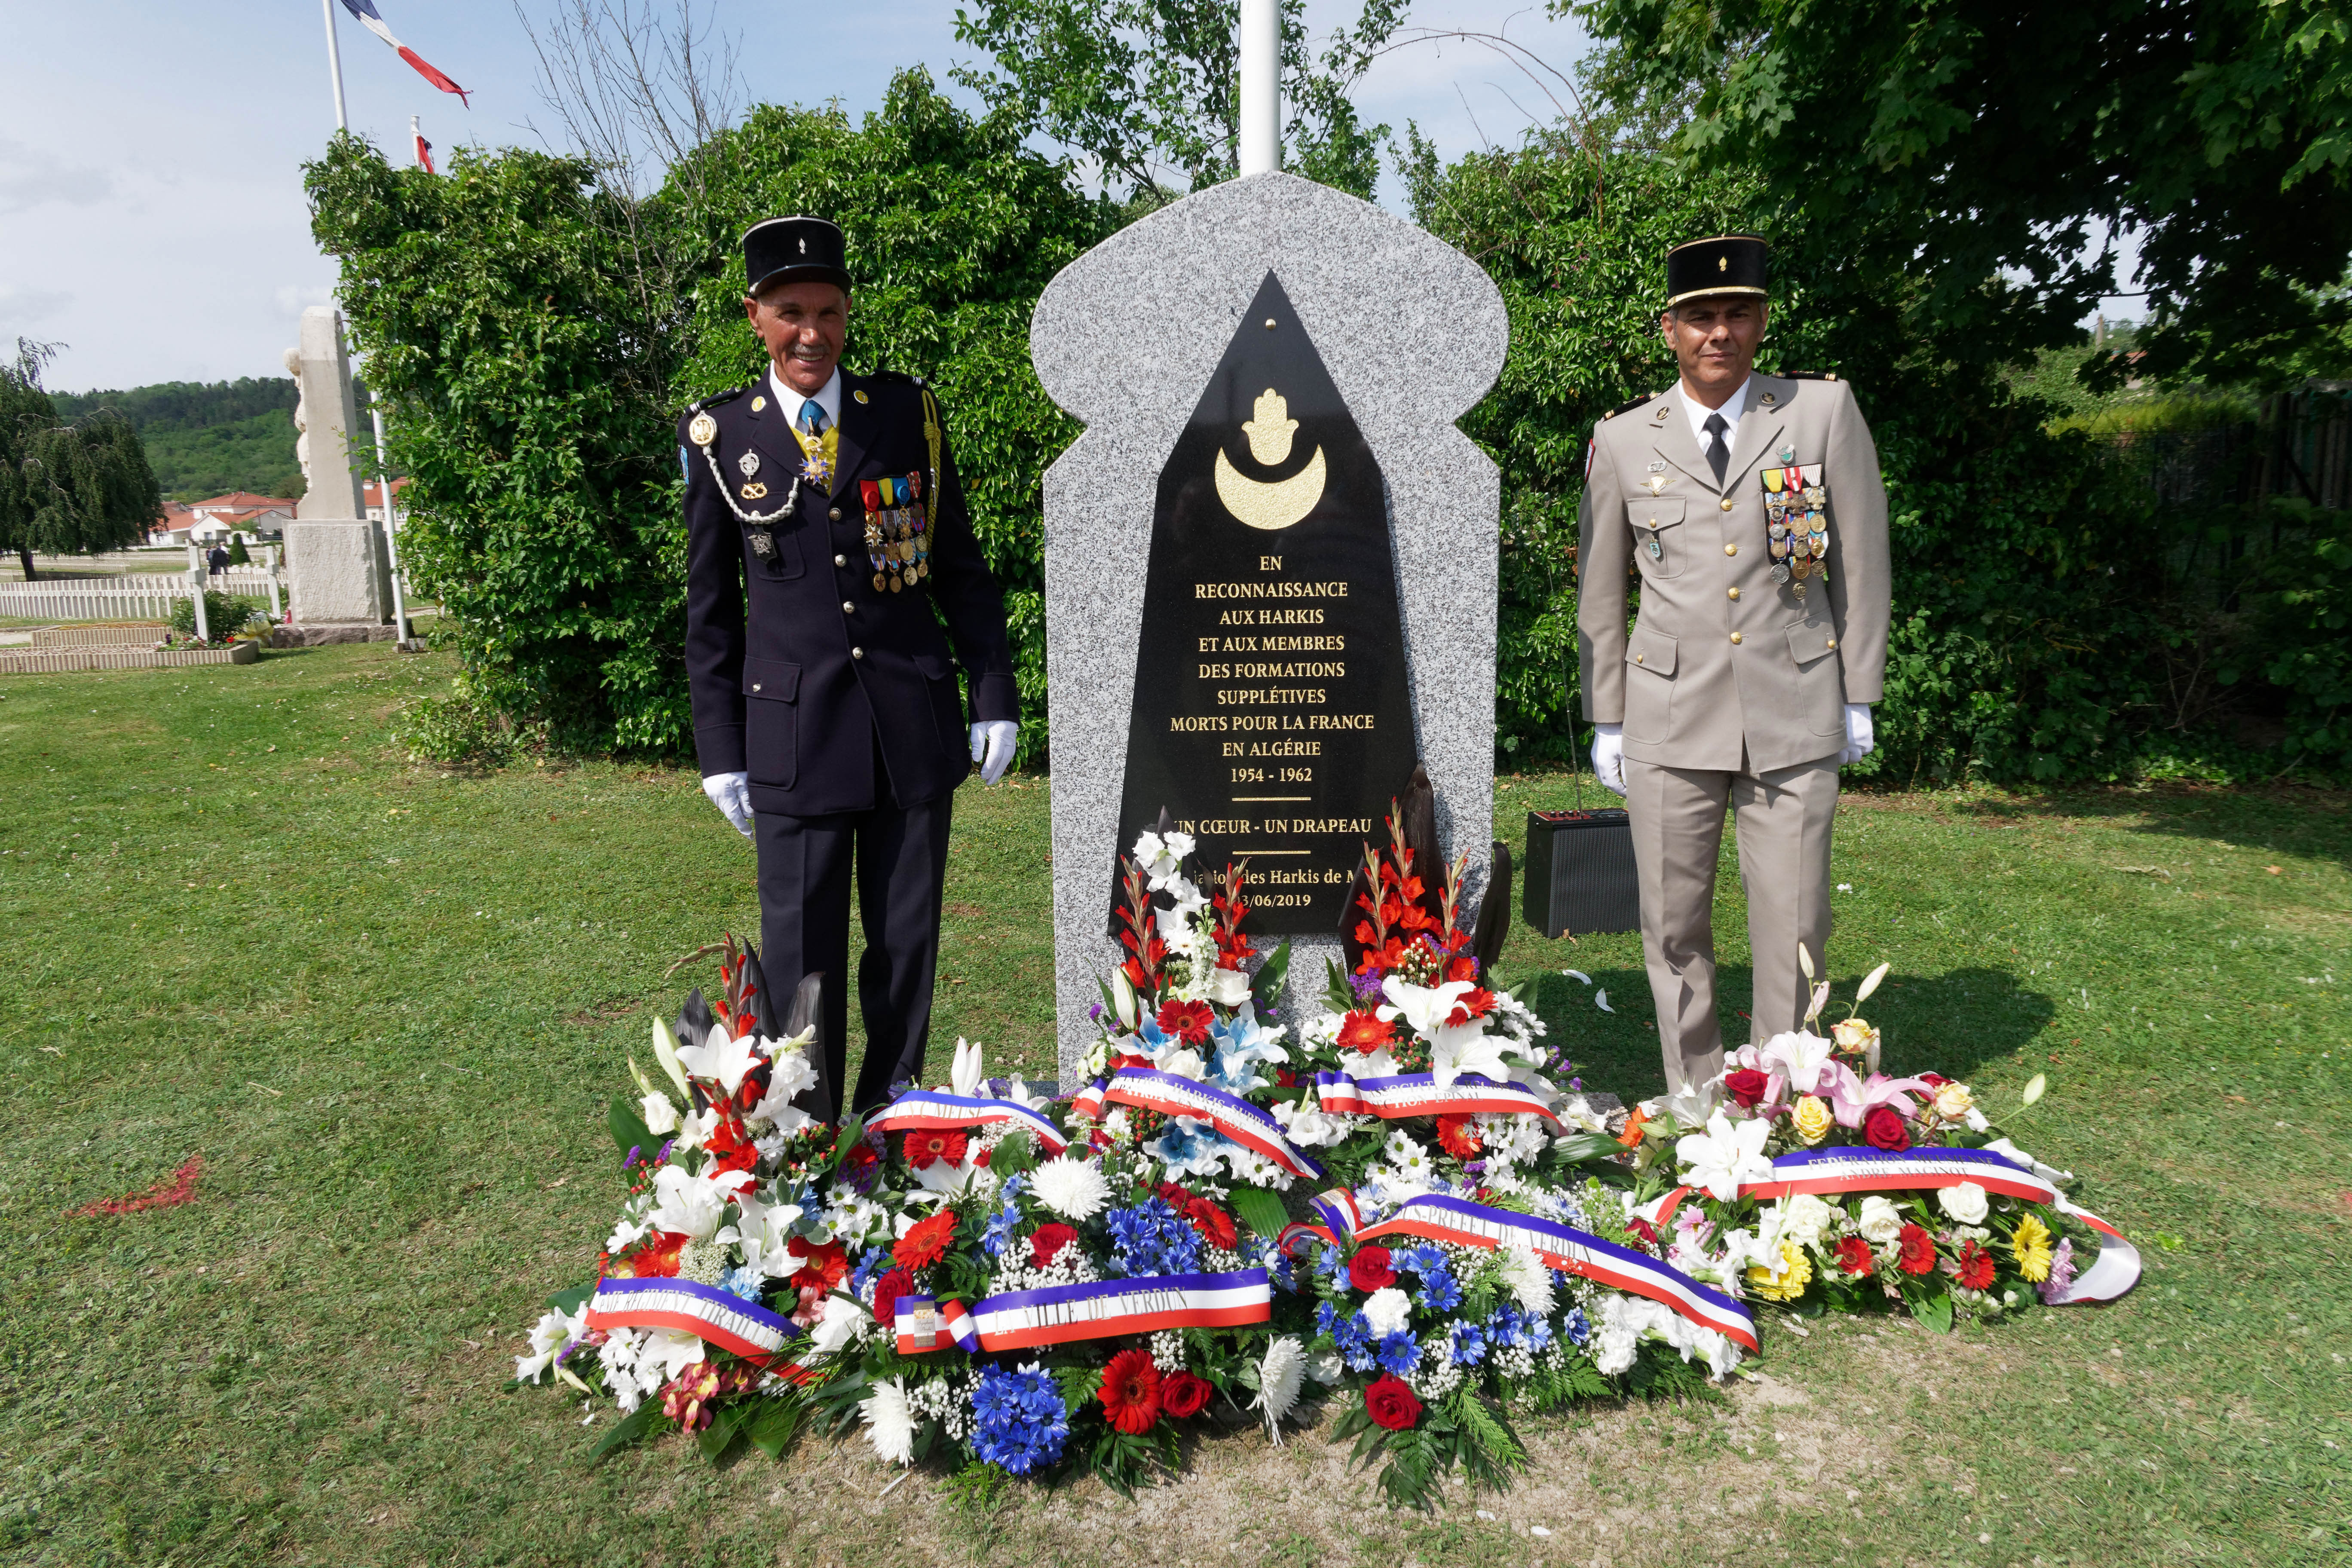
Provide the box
[1030,174,1510,1081]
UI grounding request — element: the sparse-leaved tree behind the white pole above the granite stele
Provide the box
[955,0,1409,209]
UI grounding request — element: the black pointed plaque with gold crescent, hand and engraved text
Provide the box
[1112,273,1414,933]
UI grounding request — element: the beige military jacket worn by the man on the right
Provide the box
[1576,374,1889,773]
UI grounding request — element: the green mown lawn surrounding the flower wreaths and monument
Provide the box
[0,644,2352,1568]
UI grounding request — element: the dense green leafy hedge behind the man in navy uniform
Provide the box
[308,70,1115,750]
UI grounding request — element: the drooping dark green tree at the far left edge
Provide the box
[0,339,162,583]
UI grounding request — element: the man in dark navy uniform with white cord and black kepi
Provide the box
[677,219,1021,1119]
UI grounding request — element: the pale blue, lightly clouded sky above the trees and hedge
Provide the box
[0,0,1583,390]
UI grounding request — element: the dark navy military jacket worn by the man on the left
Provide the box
[677,369,1021,816]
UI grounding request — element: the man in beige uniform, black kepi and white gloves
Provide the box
[1576,235,1886,1093]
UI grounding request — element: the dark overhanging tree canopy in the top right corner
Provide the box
[1553,0,2352,376]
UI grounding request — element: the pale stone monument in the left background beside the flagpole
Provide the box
[285,306,393,642]
